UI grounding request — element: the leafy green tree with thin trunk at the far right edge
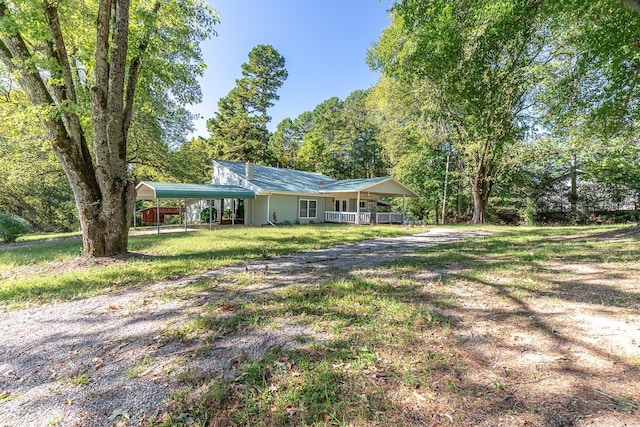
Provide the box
[539,0,640,211]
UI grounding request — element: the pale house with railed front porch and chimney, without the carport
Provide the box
[213,160,418,225]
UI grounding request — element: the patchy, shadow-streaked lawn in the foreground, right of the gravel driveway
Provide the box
[153,227,640,426]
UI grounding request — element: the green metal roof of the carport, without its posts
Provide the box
[136,181,256,200]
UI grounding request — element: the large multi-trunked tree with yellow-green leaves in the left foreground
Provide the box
[0,0,215,256]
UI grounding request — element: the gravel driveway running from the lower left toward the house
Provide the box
[0,229,486,426]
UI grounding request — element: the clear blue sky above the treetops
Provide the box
[189,0,391,137]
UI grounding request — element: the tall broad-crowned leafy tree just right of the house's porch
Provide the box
[370,0,546,223]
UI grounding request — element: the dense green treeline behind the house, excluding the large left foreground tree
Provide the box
[0,0,640,228]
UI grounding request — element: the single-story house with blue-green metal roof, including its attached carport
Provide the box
[134,160,418,227]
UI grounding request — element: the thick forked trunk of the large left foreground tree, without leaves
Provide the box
[0,0,150,256]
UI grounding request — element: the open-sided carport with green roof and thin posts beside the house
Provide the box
[133,181,256,234]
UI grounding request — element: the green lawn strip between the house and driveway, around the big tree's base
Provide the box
[0,225,419,309]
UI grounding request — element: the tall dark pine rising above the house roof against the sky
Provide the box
[207,44,288,164]
